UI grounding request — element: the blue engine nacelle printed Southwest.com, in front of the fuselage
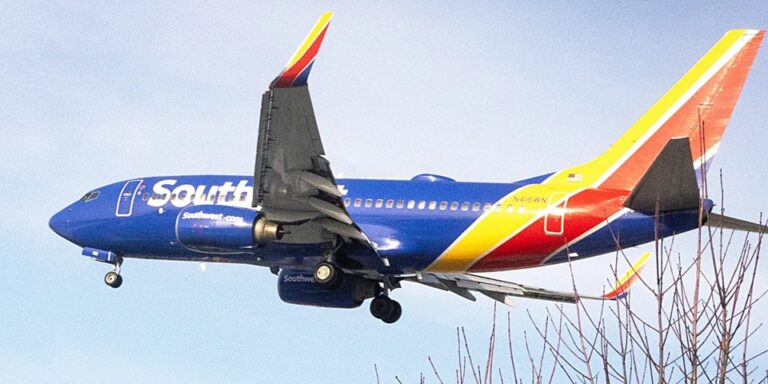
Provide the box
[176,205,282,252]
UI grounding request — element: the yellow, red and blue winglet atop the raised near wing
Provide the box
[269,12,333,89]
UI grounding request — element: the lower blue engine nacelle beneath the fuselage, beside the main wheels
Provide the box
[277,270,379,308]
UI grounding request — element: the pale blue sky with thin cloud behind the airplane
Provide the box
[0,1,768,383]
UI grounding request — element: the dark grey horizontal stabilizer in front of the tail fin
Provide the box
[624,137,699,213]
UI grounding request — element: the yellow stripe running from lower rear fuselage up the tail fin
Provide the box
[427,30,748,272]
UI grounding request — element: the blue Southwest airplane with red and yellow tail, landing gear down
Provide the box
[49,12,766,323]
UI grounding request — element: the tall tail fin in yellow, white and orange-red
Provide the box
[551,29,764,190]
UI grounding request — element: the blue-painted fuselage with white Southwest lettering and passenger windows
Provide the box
[50,175,711,273]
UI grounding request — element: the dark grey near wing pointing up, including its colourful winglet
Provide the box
[252,12,381,267]
